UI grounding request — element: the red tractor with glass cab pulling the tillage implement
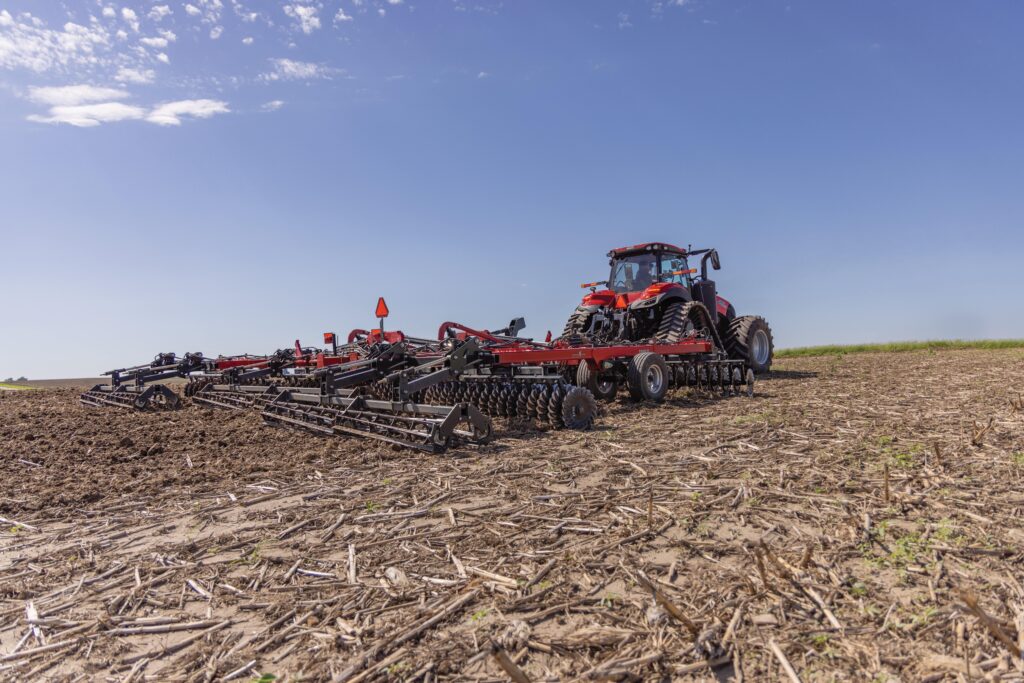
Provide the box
[562,242,774,373]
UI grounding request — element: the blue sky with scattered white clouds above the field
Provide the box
[0,0,1024,378]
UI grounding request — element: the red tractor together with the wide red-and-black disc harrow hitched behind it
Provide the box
[81,243,772,453]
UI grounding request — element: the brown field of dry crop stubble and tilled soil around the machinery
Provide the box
[0,350,1024,681]
